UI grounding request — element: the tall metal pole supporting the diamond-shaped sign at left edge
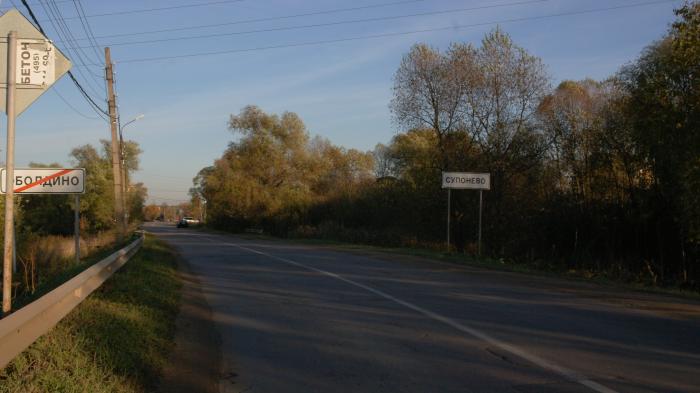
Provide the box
[2,31,17,314]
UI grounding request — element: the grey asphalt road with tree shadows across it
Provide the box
[147,224,700,393]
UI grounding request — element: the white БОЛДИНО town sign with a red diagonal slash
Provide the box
[0,168,85,194]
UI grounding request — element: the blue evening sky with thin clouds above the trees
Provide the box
[0,0,682,203]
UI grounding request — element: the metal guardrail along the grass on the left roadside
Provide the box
[0,234,144,369]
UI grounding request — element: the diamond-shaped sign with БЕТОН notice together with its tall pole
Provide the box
[0,9,71,314]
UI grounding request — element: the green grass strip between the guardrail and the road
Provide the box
[0,236,181,393]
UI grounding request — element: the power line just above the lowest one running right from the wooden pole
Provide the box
[76,0,550,46]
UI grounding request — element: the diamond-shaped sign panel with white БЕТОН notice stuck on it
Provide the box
[0,9,71,115]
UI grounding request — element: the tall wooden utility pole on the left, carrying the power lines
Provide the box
[105,47,126,240]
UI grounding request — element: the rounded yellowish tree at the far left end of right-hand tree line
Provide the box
[200,106,314,229]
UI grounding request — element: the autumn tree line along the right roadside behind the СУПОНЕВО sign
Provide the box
[191,1,700,286]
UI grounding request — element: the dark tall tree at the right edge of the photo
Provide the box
[620,1,700,280]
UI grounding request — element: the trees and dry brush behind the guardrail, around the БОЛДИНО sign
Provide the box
[0,140,147,295]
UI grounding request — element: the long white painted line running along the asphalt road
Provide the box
[224,239,617,393]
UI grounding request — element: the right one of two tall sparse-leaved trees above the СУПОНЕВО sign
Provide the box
[460,28,549,173]
